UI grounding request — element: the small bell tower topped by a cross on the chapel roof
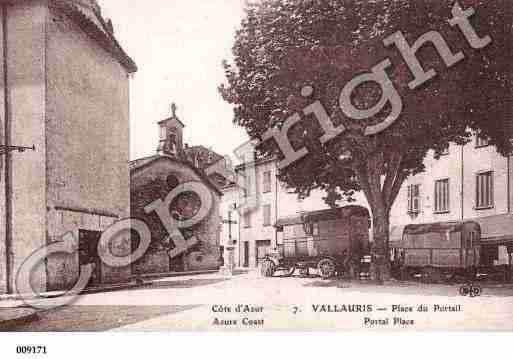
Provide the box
[157,102,185,157]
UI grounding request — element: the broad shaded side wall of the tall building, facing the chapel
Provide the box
[45,2,131,289]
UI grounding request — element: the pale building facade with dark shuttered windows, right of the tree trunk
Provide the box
[390,136,513,264]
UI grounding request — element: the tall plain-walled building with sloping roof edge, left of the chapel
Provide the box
[0,0,136,292]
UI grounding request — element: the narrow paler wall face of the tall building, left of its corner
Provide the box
[0,2,47,292]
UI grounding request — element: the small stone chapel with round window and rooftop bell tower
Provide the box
[130,106,222,274]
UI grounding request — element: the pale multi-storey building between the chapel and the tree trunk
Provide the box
[221,159,366,268]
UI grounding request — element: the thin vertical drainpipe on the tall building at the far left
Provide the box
[2,4,13,293]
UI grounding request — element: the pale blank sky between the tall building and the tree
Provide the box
[98,0,247,159]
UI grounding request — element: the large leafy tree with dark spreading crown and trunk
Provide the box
[219,0,513,278]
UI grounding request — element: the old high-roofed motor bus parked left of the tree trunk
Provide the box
[261,206,369,279]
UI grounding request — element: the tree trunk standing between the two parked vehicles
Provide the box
[371,206,390,283]
